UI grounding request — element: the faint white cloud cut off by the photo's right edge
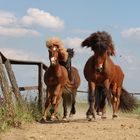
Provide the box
[121,28,140,39]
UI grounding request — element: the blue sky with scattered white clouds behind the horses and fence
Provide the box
[0,0,140,92]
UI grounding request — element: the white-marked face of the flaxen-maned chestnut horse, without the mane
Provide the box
[49,46,59,65]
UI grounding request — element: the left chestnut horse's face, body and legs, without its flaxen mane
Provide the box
[43,46,80,120]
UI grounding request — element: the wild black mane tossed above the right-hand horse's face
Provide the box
[81,31,115,55]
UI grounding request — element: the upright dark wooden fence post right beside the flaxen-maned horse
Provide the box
[38,63,44,113]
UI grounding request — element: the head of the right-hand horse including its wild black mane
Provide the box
[81,31,115,72]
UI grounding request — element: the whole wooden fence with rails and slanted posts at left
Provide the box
[0,52,48,112]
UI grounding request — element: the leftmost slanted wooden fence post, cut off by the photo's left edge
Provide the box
[0,55,15,119]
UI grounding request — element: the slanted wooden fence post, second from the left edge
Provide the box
[5,59,25,107]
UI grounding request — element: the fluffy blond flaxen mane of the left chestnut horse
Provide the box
[46,37,68,62]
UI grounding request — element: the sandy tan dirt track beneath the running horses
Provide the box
[0,109,140,140]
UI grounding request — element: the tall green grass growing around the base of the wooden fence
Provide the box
[0,95,41,132]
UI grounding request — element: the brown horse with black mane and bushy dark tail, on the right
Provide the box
[81,31,136,119]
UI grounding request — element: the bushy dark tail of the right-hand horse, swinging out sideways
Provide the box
[119,88,138,112]
